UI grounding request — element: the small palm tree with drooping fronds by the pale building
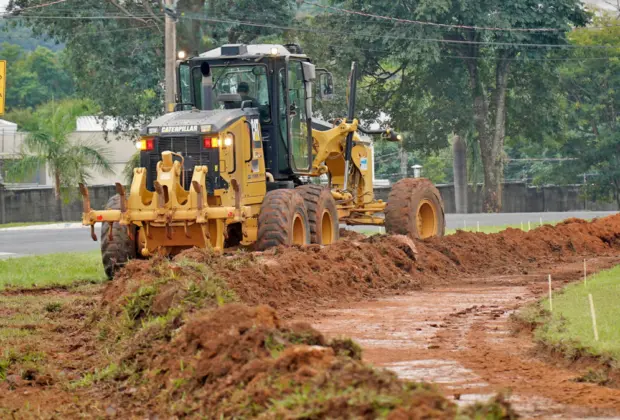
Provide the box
[7,100,113,220]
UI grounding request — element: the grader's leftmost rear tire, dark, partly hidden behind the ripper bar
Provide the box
[101,195,137,280]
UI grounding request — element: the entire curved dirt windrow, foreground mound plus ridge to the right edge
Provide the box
[53,216,620,418]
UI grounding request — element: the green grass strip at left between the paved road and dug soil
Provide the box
[0,251,105,290]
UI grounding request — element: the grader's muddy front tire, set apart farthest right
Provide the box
[385,178,446,239]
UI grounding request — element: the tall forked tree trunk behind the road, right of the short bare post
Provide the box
[467,56,510,213]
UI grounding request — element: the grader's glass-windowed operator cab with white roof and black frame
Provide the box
[178,44,324,180]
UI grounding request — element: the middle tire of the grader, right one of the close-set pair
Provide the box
[296,184,340,245]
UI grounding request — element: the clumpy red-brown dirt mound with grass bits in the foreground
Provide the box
[104,305,456,419]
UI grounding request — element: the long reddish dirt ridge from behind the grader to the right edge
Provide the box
[104,215,620,317]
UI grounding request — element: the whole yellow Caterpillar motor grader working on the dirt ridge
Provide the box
[80,45,445,278]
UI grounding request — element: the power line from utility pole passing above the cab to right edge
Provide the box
[186,14,617,49]
